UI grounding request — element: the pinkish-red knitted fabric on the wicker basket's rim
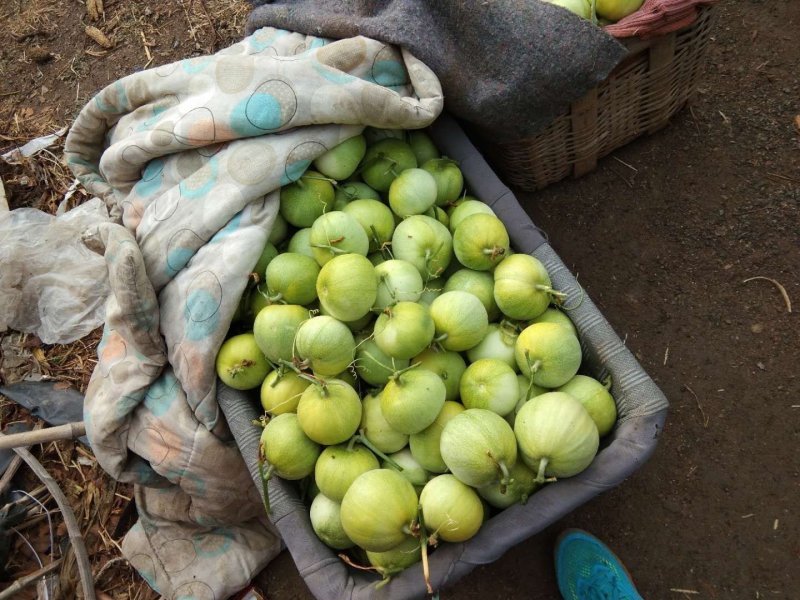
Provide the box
[604,0,717,38]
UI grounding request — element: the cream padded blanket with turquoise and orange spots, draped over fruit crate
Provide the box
[64,29,443,599]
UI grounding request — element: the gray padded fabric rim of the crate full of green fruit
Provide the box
[218,114,668,600]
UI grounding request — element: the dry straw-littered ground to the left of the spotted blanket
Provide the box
[0,0,250,600]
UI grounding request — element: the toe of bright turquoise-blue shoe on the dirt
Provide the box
[555,529,642,600]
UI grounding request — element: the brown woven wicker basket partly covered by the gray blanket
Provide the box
[479,5,716,191]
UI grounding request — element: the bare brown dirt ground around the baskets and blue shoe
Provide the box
[0,0,800,600]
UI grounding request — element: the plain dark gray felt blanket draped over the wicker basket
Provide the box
[247,0,626,139]
